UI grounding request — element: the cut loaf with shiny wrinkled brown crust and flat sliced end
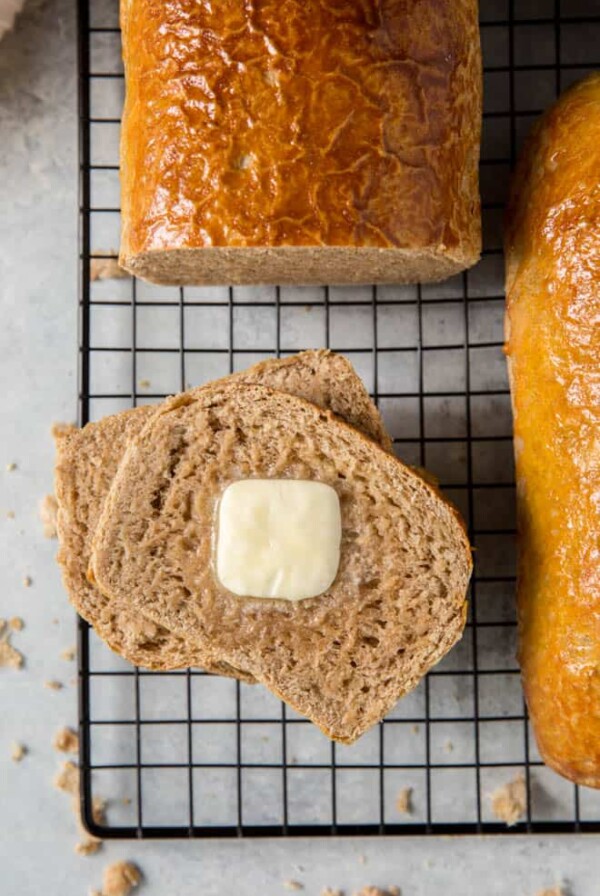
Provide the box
[119,0,481,284]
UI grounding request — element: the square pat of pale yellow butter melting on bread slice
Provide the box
[216,479,342,600]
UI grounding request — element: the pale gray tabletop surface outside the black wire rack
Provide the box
[0,0,600,896]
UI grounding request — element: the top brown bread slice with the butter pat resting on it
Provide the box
[92,383,471,743]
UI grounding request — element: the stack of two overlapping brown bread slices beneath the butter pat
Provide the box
[56,351,471,742]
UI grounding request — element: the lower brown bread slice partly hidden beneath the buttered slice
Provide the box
[55,350,391,677]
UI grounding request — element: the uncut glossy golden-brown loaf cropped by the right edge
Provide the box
[506,74,600,787]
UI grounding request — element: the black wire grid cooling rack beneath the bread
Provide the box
[79,0,600,838]
